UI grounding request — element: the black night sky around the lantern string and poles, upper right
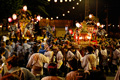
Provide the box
[46,0,120,25]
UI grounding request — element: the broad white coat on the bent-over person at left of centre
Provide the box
[26,53,49,75]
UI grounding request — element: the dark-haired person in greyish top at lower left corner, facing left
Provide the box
[6,56,36,80]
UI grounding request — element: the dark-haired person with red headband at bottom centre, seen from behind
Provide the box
[41,63,63,80]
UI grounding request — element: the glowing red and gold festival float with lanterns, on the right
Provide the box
[74,14,103,45]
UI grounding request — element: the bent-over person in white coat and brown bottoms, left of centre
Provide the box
[26,53,49,76]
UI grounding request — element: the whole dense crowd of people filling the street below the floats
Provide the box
[0,29,120,80]
